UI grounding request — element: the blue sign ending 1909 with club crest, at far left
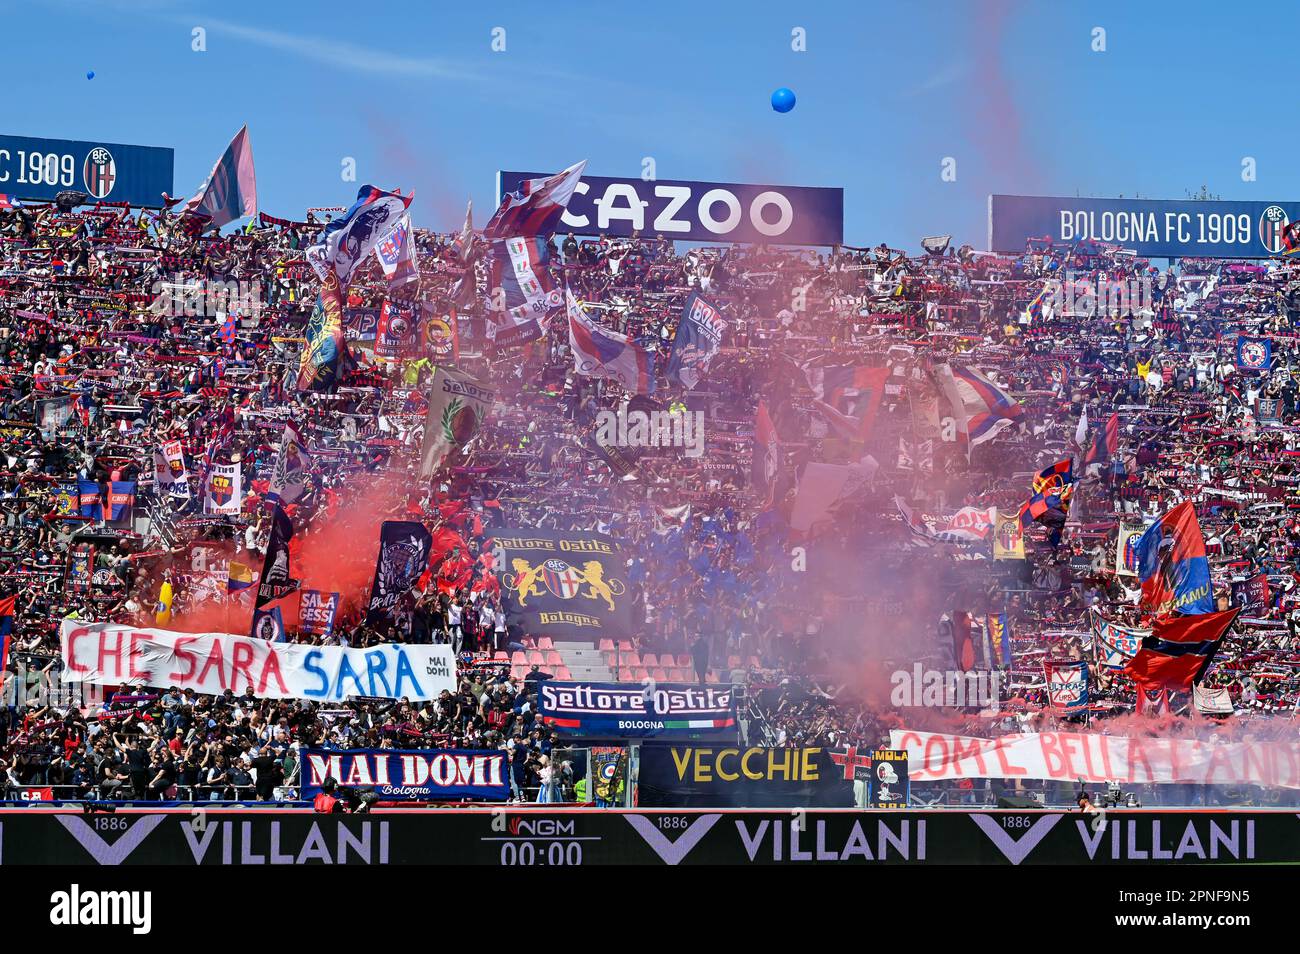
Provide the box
[0,135,176,208]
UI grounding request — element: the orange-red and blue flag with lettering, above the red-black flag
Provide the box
[1136,500,1214,616]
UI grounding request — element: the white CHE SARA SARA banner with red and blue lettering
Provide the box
[60,620,456,702]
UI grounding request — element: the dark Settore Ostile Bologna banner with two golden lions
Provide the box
[497,529,632,639]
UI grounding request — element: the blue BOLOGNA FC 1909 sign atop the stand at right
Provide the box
[988,195,1300,259]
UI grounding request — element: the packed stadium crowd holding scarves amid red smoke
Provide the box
[0,183,1300,801]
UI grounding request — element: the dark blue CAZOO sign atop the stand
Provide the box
[497,172,844,246]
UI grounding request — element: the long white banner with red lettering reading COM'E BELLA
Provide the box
[889,729,1300,789]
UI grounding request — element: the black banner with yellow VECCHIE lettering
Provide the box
[637,745,854,808]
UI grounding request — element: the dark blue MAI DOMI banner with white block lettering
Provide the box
[303,749,510,802]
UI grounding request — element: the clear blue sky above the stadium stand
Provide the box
[0,0,1300,250]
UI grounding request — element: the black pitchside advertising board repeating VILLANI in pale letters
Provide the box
[0,807,1300,867]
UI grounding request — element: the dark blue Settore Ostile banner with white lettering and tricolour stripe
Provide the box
[538,680,737,741]
